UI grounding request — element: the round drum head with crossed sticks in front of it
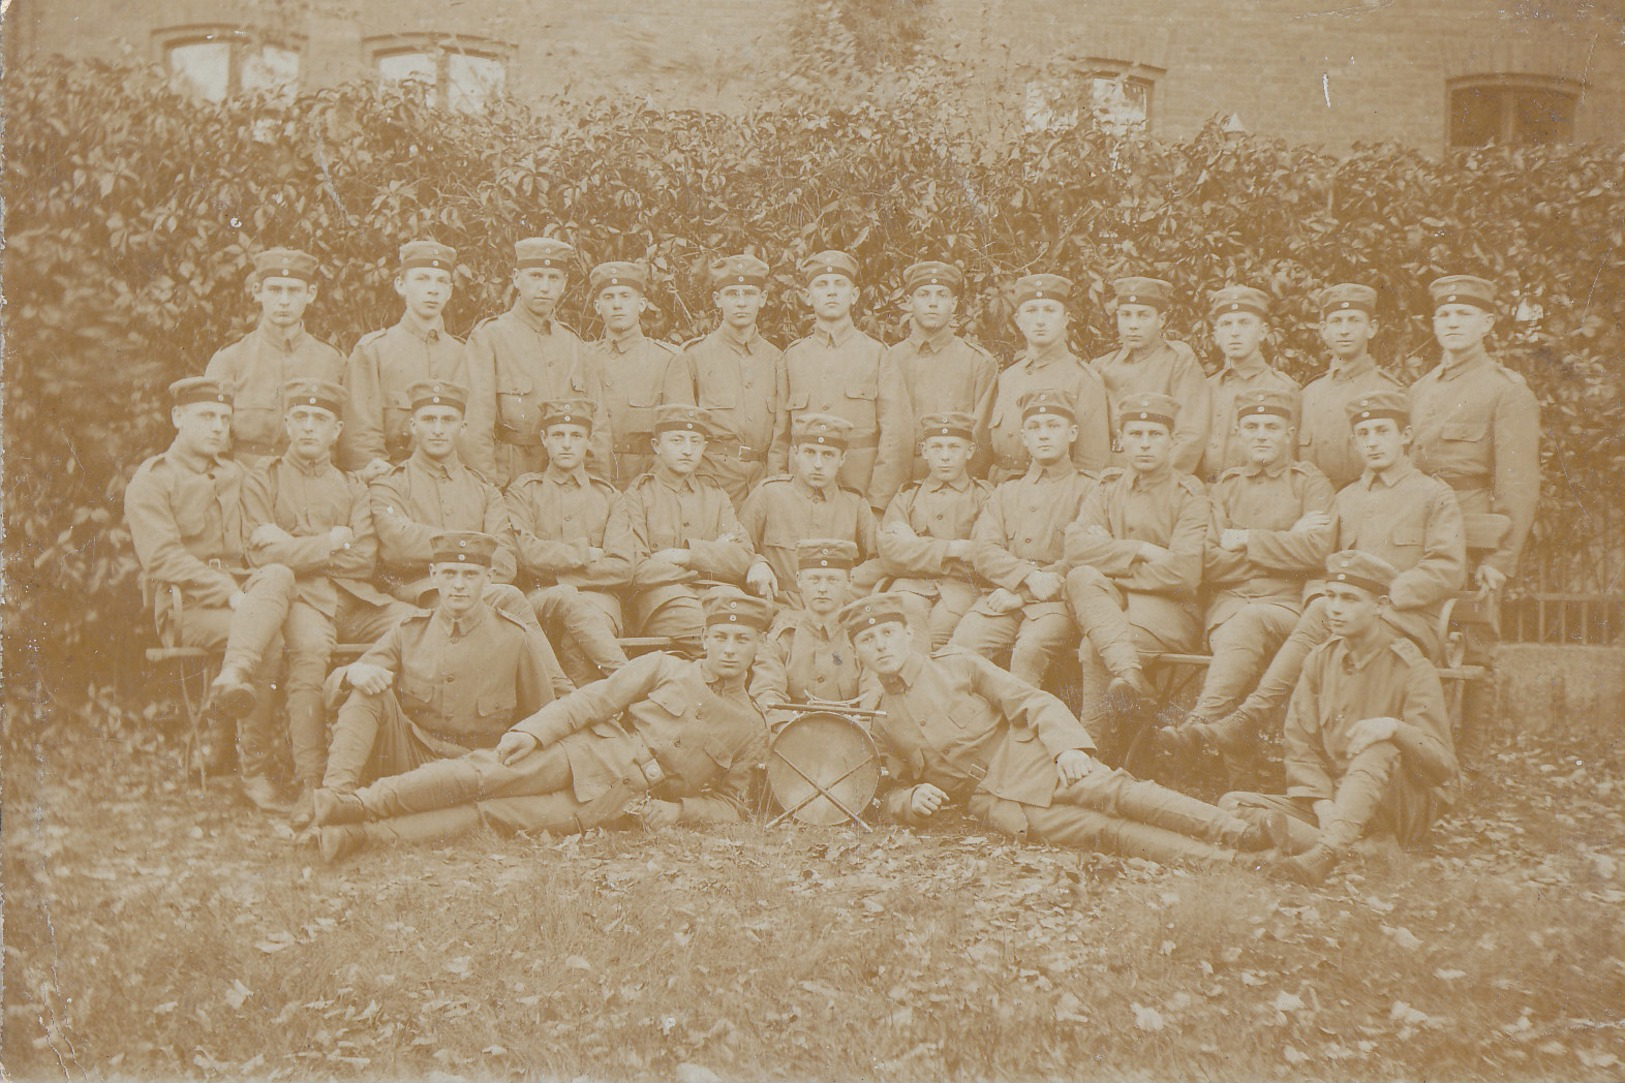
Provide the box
[767,712,881,826]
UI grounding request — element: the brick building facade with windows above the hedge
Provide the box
[5,0,1625,151]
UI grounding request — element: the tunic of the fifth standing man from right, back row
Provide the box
[988,343,1112,481]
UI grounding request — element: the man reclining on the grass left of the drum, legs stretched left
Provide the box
[317,587,770,860]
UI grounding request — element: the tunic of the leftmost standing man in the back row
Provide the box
[203,324,345,468]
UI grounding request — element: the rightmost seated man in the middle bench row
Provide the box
[1207,390,1467,756]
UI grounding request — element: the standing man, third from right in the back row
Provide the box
[1196,286,1318,478]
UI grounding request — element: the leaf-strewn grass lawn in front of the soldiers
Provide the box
[3,715,1625,1081]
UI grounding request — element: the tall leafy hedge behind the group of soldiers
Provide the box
[3,63,1625,735]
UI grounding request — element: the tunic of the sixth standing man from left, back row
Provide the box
[767,320,915,511]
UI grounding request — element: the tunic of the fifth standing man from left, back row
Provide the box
[661,325,780,507]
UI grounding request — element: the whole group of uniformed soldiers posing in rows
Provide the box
[125,237,1539,883]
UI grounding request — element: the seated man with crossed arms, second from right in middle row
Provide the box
[1162,389,1333,777]
